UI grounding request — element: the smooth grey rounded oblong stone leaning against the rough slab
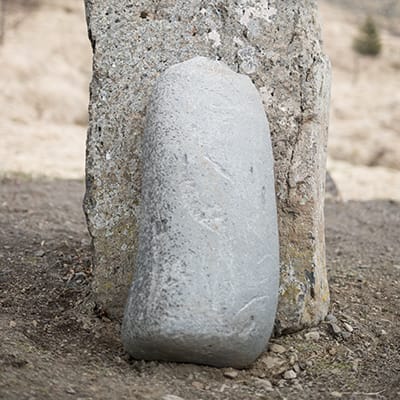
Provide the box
[122,57,279,367]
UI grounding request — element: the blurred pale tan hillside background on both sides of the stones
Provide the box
[0,0,400,200]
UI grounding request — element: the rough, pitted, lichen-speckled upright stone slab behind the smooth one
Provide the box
[85,0,330,331]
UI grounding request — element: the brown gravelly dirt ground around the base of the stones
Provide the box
[0,178,400,400]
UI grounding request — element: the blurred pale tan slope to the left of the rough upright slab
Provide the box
[0,0,91,178]
